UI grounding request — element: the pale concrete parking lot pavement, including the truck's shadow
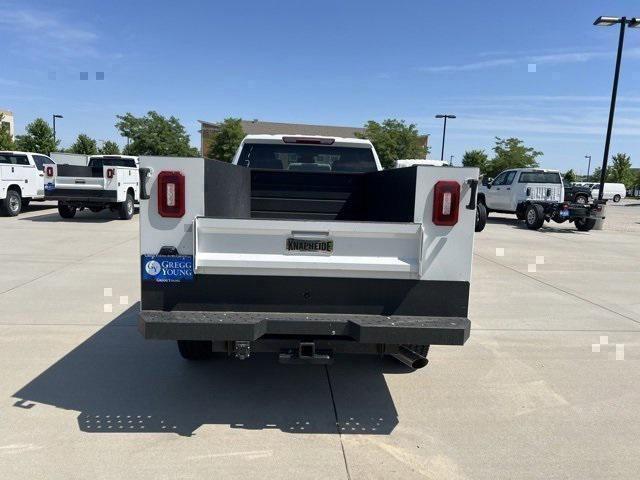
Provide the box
[0,202,640,480]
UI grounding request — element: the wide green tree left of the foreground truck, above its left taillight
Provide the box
[116,111,199,157]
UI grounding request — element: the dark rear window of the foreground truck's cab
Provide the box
[238,143,378,173]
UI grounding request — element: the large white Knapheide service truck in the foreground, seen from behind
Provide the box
[139,135,478,368]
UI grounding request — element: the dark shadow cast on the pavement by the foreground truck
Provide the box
[13,304,402,436]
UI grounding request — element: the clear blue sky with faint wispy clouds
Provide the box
[0,0,640,171]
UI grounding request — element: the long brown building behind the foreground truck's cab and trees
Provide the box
[198,120,429,157]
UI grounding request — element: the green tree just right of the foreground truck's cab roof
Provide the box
[356,118,429,168]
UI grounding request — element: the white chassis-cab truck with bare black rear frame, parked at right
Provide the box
[478,168,602,232]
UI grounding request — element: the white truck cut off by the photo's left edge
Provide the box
[0,151,54,217]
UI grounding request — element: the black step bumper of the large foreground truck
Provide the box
[138,310,471,345]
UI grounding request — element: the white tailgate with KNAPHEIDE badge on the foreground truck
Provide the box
[193,217,423,280]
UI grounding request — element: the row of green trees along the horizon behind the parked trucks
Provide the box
[0,111,640,188]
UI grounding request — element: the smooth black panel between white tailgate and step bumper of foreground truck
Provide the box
[141,275,469,317]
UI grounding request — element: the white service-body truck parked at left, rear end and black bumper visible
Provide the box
[44,155,140,220]
